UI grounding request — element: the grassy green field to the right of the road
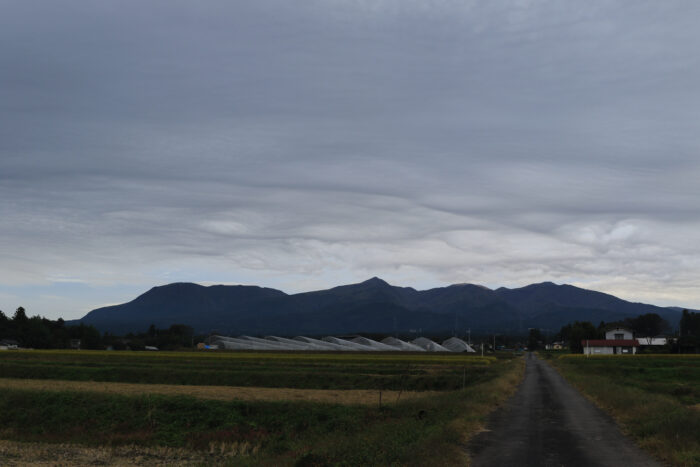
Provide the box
[550,355,700,466]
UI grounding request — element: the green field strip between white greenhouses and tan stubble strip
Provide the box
[0,351,499,391]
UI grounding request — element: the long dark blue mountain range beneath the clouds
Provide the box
[74,277,680,335]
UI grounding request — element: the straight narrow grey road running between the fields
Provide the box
[469,353,660,467]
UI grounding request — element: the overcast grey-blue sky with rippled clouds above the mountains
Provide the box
[0,0,700,319]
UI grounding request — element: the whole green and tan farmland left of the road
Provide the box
[0,351,523,465]
